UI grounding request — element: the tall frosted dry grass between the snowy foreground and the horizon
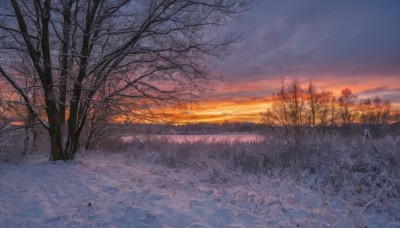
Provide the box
[114,131,400,220]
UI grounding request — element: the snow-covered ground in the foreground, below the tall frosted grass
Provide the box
[0,153,400,227]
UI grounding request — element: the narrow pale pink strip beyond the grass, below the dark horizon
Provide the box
[121,134,264,143]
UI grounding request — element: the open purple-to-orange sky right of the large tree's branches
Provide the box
[184,0,400,122]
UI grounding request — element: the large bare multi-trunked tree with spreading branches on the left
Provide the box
[0,0,249,160]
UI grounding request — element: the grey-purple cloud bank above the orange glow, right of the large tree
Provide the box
[218,0,400,81]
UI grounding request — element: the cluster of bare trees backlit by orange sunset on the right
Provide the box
[261,80,400,129]
